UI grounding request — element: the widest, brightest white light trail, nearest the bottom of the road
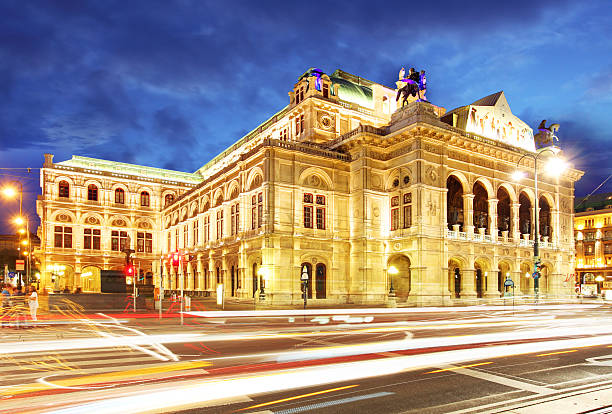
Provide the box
[39,335,612,414]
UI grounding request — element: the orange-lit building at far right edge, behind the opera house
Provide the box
[574,193,612,294]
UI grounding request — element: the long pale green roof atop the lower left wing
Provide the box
[55,155,202,184]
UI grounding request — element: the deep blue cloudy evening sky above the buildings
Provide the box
[0,0,612,232]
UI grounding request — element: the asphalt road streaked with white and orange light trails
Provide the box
[0,305,612,414]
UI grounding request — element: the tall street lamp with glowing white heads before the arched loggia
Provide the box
[512,146,566,298]
